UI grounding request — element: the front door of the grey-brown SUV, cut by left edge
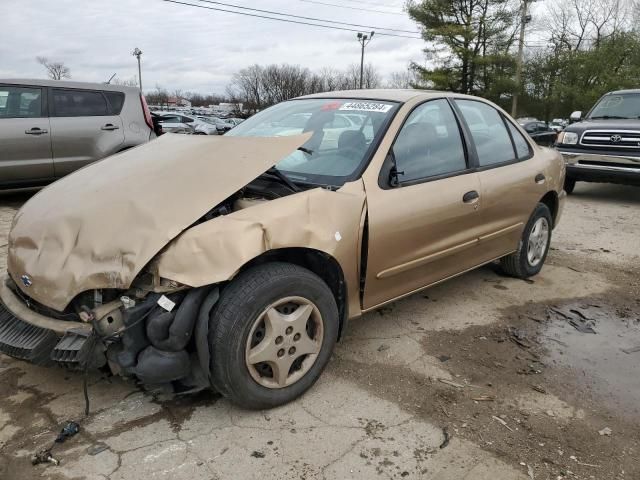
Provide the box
[0,85,54,188]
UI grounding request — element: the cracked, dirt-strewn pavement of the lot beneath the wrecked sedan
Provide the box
[0,184,640,480]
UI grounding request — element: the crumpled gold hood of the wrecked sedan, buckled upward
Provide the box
[7,134,308,310]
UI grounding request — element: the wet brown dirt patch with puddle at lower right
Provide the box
[336,293,640,479]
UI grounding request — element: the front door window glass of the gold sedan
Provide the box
[393,99,467,183]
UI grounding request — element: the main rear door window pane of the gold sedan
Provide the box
[455,99,515,167]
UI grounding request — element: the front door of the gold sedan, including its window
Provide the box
[363,99,482,310]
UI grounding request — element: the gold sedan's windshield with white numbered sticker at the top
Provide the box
[226,98,398,186]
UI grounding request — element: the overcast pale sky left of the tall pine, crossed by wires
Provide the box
[0,0,424,93]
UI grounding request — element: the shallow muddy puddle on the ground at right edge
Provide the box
[544,304,640,419]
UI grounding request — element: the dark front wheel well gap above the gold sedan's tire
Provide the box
[241,248,349,340]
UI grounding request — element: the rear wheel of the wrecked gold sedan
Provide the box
[500,203,553,278]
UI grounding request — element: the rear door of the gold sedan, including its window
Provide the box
[454,99,546,261]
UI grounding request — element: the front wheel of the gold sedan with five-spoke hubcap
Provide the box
[210,262,339,409]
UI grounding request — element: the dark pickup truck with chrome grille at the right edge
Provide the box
[555,89,640,193]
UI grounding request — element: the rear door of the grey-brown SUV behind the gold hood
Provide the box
[49,88,124,177]
